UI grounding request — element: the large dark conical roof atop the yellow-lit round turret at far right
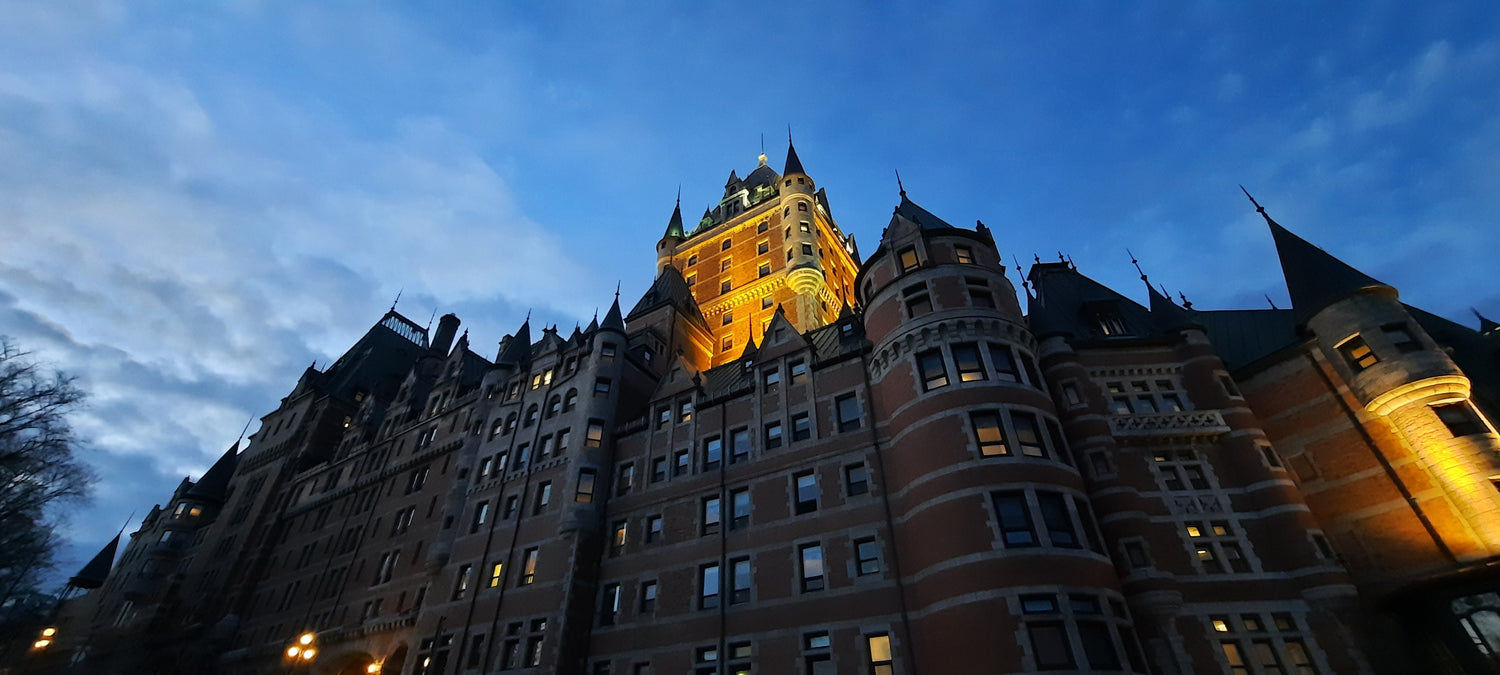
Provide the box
[1241,188,1395,326]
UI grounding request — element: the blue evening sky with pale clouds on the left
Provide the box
[0,0,1500,573]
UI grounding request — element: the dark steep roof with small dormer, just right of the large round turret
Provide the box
[1028,263,1158,341]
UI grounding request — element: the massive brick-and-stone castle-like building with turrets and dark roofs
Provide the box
[41,147,1500,675]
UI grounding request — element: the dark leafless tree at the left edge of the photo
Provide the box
[0,336,95,606]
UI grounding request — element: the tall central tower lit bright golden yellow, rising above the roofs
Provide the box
[657,140,858,366]
